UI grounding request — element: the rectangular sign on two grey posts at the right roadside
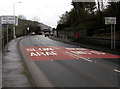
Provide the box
[105,17,116,49]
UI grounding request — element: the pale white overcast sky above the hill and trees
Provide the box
[0,0,73,27]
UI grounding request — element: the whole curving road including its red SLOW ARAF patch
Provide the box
[20,35,120,87]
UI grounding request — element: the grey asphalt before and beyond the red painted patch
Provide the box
[20,35,120,87]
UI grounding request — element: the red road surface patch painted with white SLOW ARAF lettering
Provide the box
[23,46,120,61]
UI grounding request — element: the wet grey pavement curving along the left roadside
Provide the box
[0,38,31,87]
